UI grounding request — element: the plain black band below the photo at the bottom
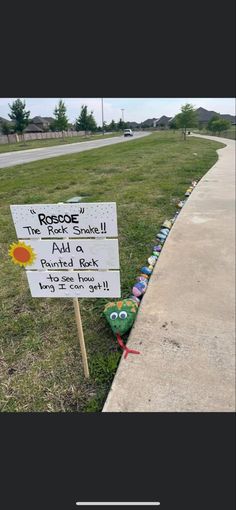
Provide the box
[0,413,235,510]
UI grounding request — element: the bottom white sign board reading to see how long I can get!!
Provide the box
[26,271,120,298]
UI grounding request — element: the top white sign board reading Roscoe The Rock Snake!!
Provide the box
[10,202,118,239]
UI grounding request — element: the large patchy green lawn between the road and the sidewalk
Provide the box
[0,132,223,412]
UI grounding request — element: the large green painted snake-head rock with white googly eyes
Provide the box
[104,299,138,335]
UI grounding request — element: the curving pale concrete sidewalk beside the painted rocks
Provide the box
[103,135,235,412]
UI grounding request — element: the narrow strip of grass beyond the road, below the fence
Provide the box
[0,132,122,154]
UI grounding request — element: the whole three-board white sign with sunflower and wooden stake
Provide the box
[9,202,120,378]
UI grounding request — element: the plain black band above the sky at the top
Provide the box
[0,0,236,97]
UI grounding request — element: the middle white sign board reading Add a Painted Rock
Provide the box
[20,238,120,271]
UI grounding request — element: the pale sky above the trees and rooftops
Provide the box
[0,98,235,125]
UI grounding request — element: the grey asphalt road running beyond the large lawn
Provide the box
[0,132,149,168]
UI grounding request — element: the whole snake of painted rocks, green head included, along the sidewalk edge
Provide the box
[104,181,197,342]
